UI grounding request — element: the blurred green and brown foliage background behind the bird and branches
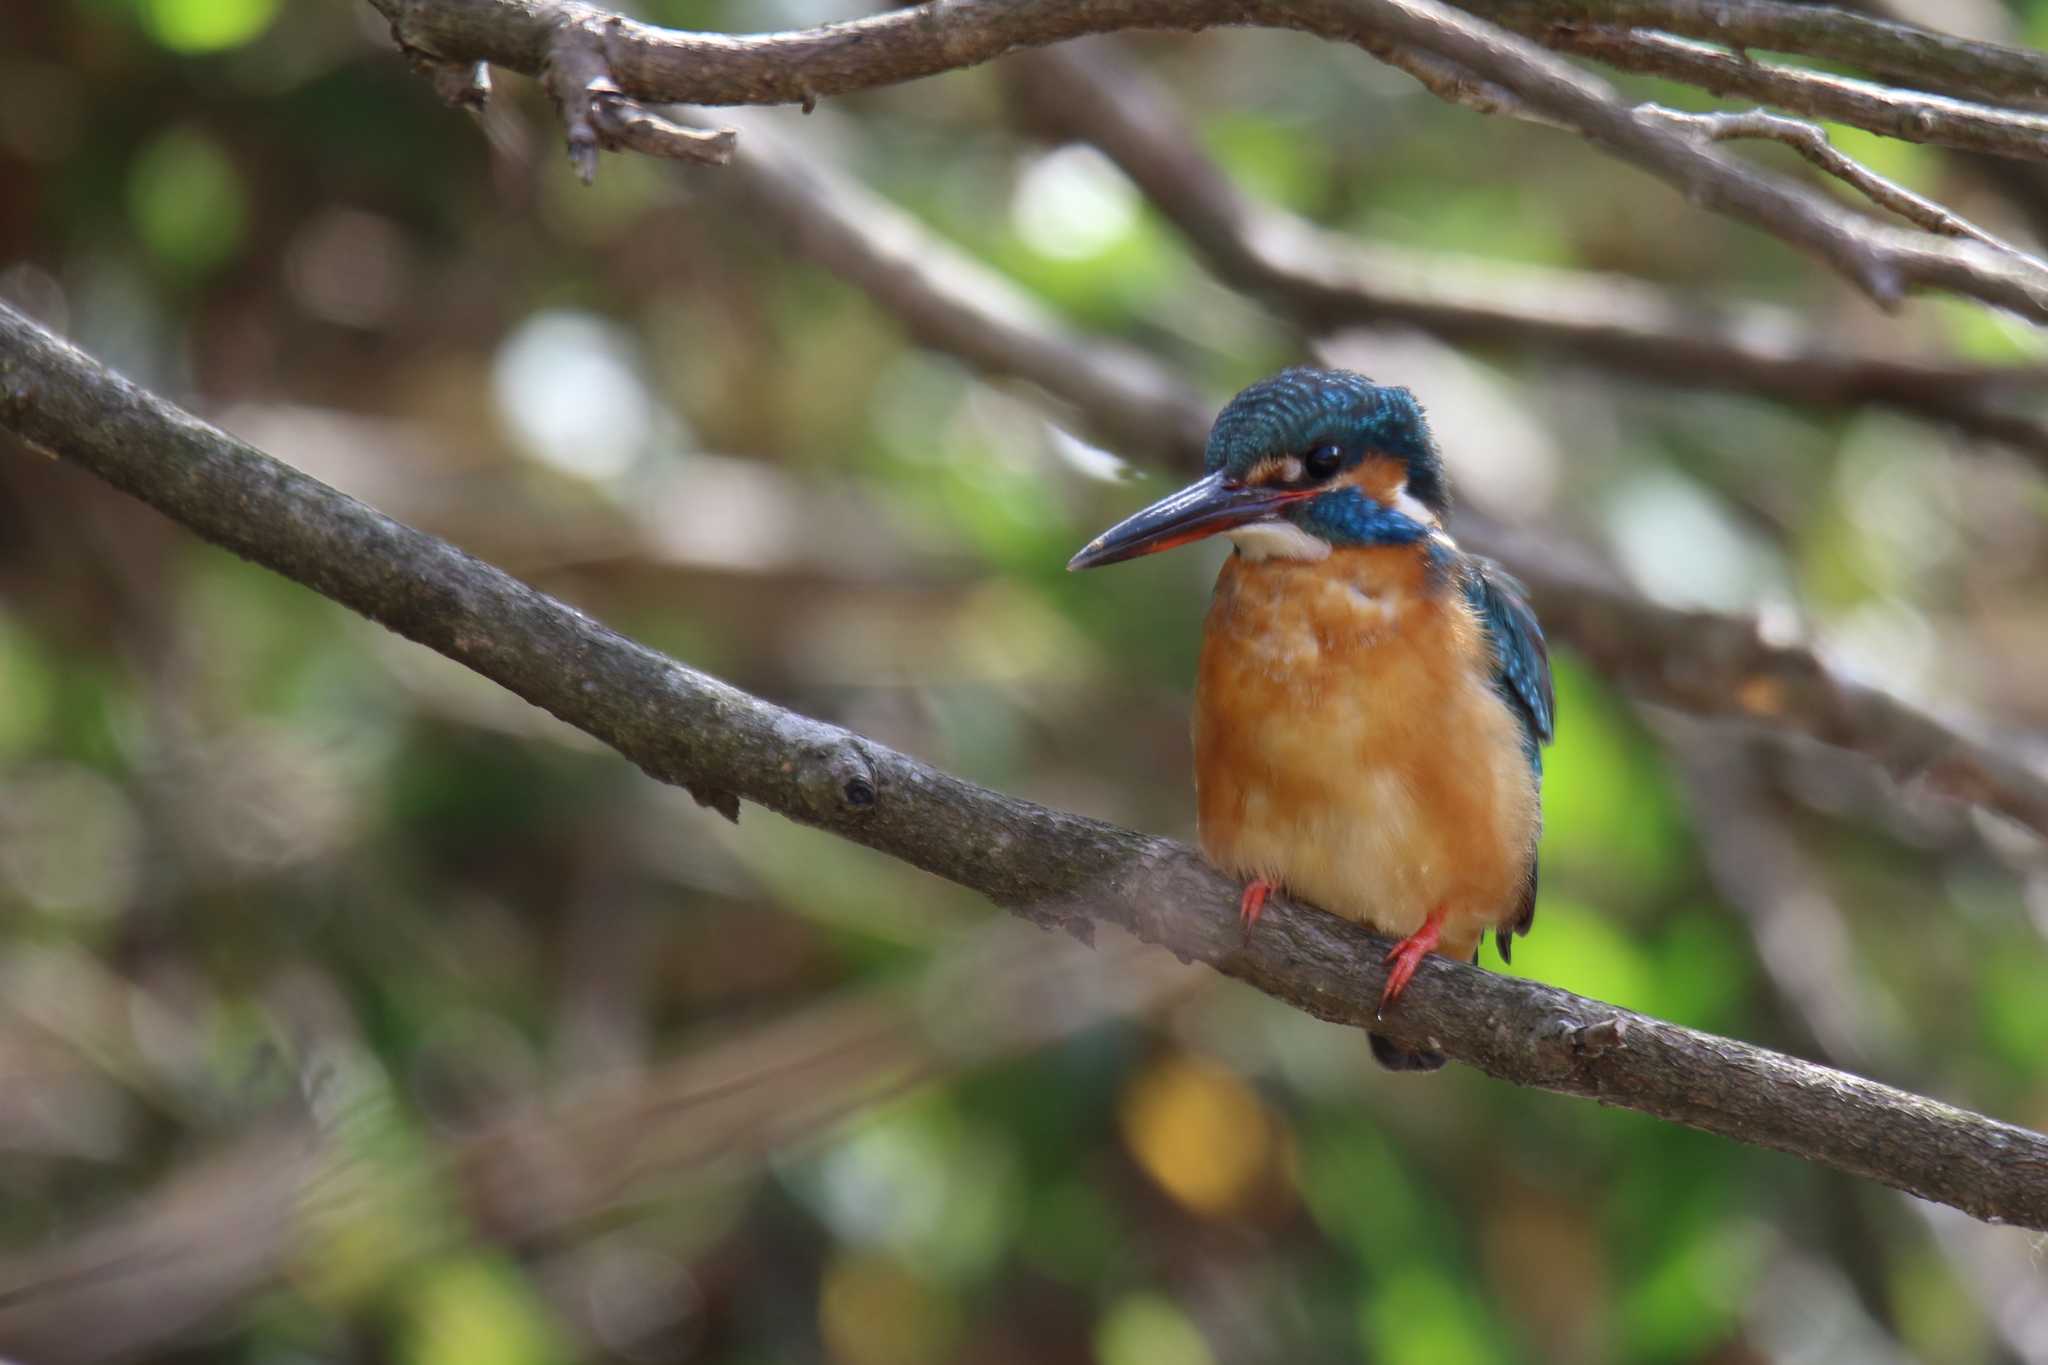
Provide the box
[0,0,2048,1365]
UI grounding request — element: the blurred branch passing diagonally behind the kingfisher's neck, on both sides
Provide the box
[692,117,2048,835]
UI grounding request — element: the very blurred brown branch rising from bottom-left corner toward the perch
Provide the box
[0,923,1212,1365]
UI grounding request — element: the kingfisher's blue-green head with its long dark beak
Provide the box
[1067,368,1450,569]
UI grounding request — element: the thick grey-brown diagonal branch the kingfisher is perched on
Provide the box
[0,307,2048,1230]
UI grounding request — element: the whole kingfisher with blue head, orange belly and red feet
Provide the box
[1067,366,1556,1070]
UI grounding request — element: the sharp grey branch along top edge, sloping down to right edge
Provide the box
[360,0,2048,321]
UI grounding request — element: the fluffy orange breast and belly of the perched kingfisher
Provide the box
[1194,546,1540,958]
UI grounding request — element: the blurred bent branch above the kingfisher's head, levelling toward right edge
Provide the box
[1004,43,2048,467]
